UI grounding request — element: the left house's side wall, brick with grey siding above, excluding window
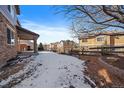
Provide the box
[0,6,17,68]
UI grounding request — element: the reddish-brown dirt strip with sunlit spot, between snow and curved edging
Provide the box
[80,55,124,87]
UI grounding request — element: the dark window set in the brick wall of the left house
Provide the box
[7,28,15,45]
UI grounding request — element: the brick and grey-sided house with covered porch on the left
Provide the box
[0,5,39,67]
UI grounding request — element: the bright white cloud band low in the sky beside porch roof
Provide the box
[22,20,71,43]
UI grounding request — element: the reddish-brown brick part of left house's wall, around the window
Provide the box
[0,13,17,68]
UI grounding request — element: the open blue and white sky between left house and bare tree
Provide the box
[18,5,71,43]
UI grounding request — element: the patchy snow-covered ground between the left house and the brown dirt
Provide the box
[0,52,90,88]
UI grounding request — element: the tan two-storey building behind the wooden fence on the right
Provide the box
[79,32,124,50]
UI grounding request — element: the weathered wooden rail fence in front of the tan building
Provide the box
[70,46,124,55]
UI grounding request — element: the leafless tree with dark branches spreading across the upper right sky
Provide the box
[55,5,124,36]
